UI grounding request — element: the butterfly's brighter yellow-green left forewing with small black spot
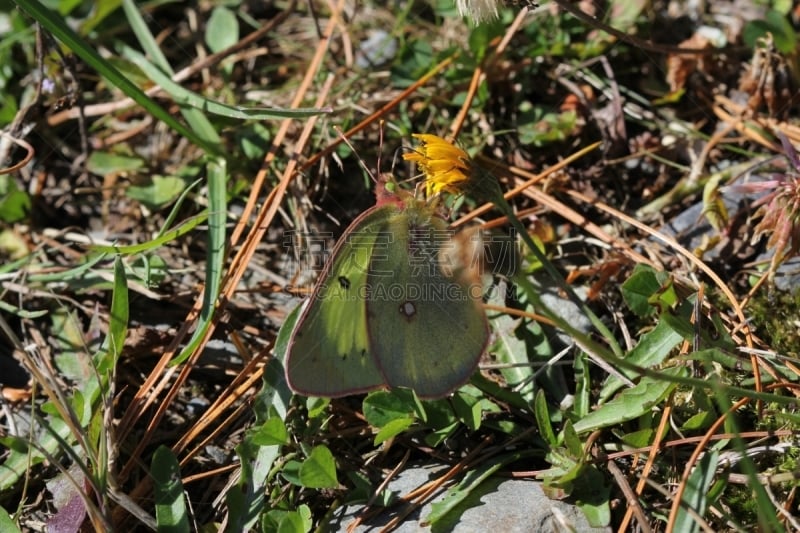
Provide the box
[286,205,397,398]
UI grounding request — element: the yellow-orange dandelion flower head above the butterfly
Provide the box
[403,133,472,197]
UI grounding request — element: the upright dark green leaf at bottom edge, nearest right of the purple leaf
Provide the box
[150,445,190,533]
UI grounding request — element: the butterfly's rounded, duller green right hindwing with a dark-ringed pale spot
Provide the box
[366,201,489,398]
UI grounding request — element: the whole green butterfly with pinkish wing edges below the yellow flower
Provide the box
[286,177,489,398]
